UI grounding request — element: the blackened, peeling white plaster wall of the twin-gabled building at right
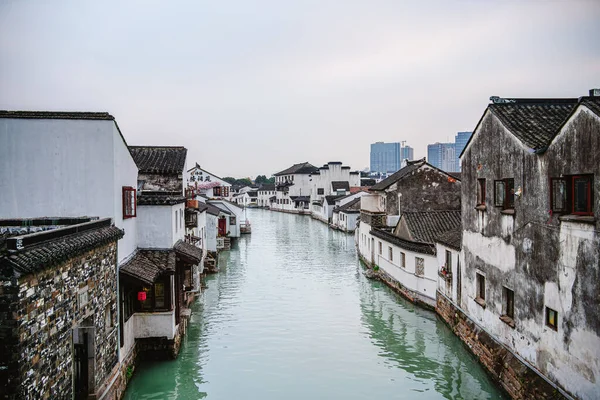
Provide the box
[460,108,600,399]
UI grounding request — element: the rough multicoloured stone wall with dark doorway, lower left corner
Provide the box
[0,243,118,399]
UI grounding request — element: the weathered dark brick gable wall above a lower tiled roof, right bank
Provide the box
[385,165,461,215]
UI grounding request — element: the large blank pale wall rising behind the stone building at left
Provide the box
[0,118,138,263]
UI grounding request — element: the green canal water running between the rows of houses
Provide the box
[125,210,504,400]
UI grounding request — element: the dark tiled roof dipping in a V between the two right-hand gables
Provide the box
[488,99,577,150]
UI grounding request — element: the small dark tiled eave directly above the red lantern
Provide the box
[119,250,175,284]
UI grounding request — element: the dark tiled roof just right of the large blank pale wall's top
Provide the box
[129,146,187,174]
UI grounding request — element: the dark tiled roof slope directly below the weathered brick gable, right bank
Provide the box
[400,210,461,243]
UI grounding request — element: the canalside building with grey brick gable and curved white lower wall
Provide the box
[356,160,461,307]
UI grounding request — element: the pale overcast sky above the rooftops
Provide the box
[0,0,600,178]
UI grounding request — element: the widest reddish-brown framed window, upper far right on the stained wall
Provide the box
[550,175,594,215]
